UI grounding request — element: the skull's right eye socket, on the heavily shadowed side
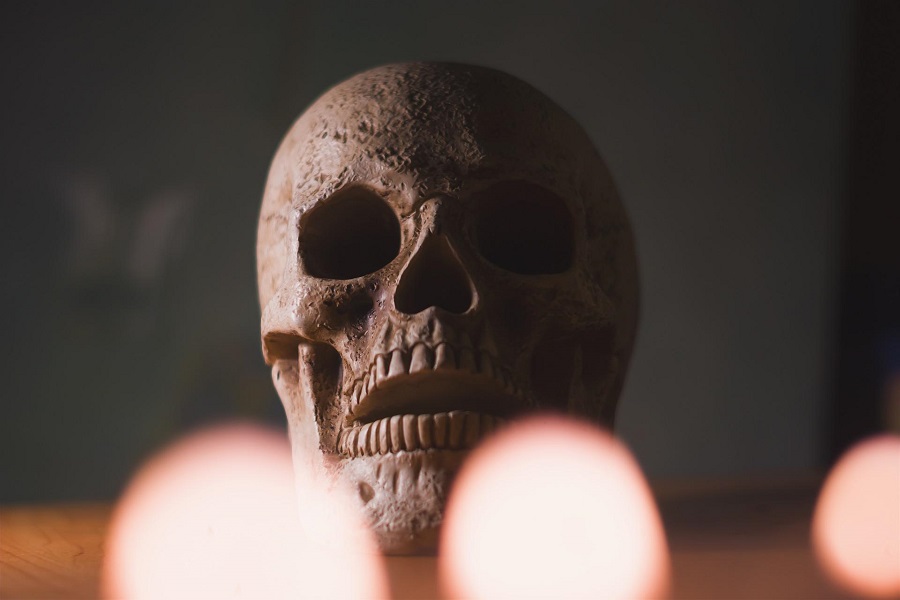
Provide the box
[474,181,575,275]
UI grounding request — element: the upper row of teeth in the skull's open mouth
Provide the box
[348,342,521,411]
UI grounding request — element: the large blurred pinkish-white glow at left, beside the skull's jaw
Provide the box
[103,425,387,599]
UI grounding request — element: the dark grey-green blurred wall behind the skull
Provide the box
[0,0,900,503]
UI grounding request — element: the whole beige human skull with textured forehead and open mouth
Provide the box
[257,63,637,553]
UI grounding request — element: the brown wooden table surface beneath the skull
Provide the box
[0,477,849,600]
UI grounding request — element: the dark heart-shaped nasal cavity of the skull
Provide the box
[394,235,472,315]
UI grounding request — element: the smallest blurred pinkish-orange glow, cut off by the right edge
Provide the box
[813,435,900,598]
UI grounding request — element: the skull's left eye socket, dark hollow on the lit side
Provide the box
[300,187,400,279]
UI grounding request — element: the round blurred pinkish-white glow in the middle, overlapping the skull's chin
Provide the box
[440,417,669,599]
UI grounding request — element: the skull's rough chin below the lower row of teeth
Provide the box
[333,450,469,555]
